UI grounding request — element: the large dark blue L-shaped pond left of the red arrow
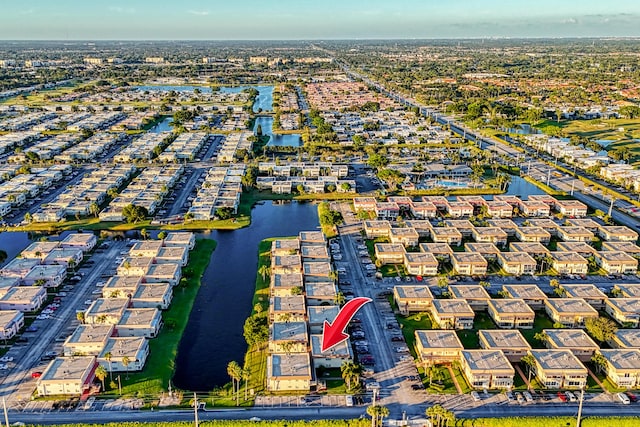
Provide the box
[173,202,318,391]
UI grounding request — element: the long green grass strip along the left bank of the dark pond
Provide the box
[105,239,216,395]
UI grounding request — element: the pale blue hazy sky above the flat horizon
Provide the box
[0,0,640,40]
